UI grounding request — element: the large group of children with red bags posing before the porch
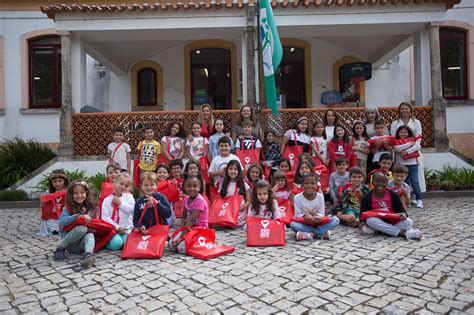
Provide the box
[42,107,421,267]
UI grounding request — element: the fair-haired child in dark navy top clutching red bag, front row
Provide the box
[133,172,173,235]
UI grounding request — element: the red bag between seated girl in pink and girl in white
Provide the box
[208,188,244,226]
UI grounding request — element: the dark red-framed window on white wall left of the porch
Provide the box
[28,36,61,108]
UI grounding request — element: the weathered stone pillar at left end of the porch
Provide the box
[58,32,74,156]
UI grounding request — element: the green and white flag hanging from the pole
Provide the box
[259,0,283,115]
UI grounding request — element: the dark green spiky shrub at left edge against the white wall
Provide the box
[0,138,55,189]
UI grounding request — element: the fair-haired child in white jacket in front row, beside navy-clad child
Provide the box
[101,173,135,250]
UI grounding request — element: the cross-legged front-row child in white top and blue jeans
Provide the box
[290,173,339,241]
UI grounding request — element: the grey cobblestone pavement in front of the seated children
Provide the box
[0,198,474,314]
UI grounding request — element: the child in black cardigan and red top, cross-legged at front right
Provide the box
[359,173,422,240]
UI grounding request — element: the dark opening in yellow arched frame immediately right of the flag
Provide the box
[275,46,306,108]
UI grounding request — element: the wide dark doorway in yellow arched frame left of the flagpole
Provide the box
[191,48,232,109]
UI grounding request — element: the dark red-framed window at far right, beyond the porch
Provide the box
[439,27,467,100]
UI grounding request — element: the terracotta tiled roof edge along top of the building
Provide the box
[41,0,461,18]
